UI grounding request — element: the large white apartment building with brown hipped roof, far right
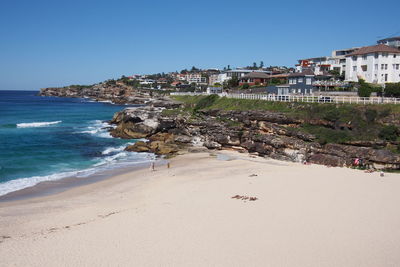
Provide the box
[345,44,400,84]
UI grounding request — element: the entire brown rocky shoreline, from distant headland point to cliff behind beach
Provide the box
[40,86,400,170]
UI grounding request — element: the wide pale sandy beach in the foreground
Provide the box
[0,151,400,266]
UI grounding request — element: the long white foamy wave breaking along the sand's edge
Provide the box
[0,152,155,196]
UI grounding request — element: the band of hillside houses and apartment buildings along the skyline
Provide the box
[122,37,400,95]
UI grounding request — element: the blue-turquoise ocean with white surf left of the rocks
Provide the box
[0,91,153,196]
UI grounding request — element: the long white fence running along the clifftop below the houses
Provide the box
[171,92,400,104]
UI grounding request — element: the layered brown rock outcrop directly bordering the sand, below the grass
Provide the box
[111,107,400,169]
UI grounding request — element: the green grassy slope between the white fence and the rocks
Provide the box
[167,95,400,150]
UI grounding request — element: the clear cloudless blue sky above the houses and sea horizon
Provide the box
[0,0,400,90]
